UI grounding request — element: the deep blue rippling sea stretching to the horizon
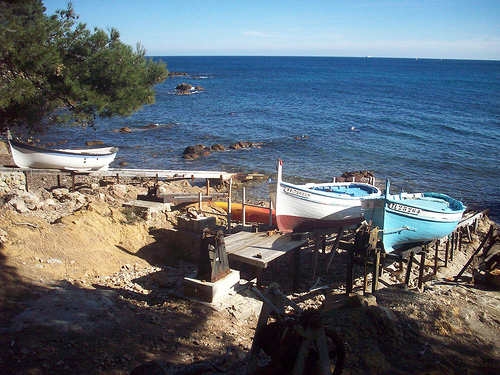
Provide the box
[33,56,500,222]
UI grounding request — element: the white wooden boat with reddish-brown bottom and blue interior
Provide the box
[269,160,381,233]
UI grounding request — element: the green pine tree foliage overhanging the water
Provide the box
[0,0,168,131]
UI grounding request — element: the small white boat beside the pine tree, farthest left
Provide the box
[9,139,118,172]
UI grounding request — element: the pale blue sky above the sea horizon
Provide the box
[43,0,500,60]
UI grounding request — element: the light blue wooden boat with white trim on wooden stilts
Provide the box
[361,180,465,253]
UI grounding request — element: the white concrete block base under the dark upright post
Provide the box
[182,270,240,303]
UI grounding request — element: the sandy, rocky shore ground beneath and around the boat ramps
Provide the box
[0,145,500,375]
